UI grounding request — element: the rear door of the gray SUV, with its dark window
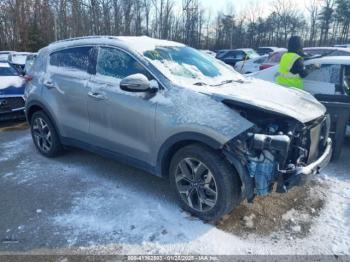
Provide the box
[43,46,94,141]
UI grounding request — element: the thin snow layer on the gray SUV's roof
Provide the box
[49,36,185,53]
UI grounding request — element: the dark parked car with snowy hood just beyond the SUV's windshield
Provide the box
[216,48,259,66]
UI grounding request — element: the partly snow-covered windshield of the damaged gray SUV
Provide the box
[144,47,243,84]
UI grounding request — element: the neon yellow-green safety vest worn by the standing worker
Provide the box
[275,53,304,89]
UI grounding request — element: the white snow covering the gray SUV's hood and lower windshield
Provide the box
[149,55,326,123]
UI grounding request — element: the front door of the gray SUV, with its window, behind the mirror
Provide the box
[88,47,156,165]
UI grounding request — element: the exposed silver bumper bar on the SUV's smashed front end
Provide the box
[284,138,333,189]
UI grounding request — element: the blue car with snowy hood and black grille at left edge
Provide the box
[0,62,25,121]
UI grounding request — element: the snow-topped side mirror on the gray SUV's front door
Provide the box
[120,74,151,93]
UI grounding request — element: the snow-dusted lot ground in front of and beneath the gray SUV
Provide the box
[0,122,350,254]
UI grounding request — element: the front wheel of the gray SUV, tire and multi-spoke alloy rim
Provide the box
[170,144,240,222]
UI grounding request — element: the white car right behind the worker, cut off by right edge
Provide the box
[251,56,350,95]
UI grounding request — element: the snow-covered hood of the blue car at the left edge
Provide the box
[0,76,25,96]
